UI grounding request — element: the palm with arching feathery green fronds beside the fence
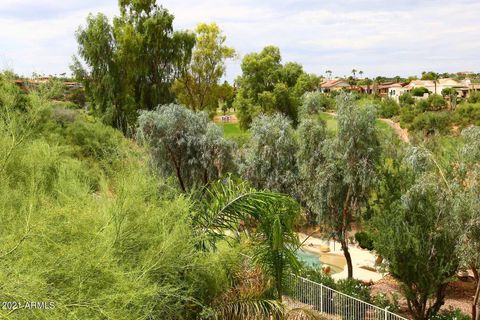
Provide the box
[193,178,300,301]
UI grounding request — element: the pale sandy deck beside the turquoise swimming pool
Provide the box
[298,232,384,282]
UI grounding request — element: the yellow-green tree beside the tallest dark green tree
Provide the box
[173,23,235,112]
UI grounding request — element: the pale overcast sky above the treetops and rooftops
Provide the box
[0,0,480,80]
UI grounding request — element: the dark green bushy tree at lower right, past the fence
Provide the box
[372,148,459,320]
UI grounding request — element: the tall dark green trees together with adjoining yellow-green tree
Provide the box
[72,0,235,134]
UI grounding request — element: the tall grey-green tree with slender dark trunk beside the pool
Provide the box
[311,94,380,278]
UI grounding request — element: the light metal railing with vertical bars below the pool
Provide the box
[285,274,407,320]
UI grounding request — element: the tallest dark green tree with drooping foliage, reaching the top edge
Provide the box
[72,0,195,133]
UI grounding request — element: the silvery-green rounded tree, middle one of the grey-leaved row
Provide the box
[239,113,298,196]
